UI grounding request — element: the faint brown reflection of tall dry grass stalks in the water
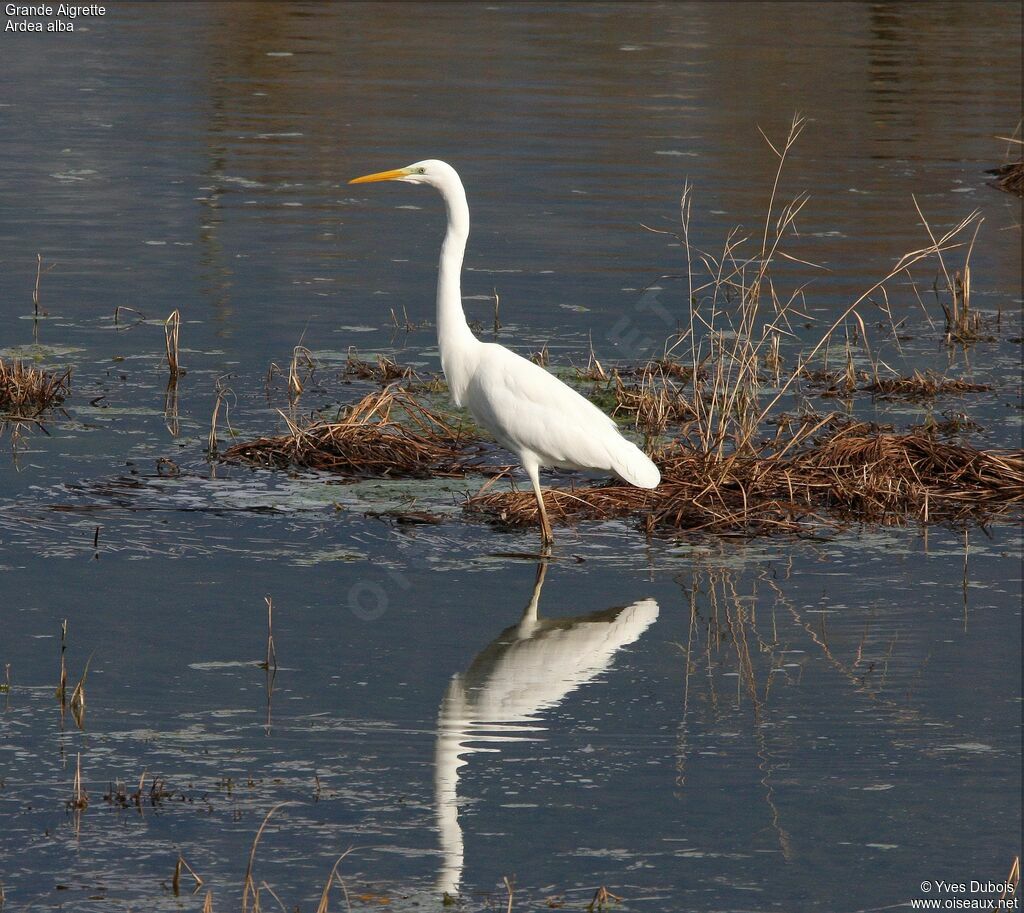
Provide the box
[676,548,991,860]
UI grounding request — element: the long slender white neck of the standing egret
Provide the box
[437,179,478,405]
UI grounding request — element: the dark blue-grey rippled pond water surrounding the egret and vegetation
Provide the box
[0,3,1021,911]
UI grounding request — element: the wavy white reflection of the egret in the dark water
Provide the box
[434,563,658,896]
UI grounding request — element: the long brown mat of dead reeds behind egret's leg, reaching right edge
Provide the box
[466,419,1024,535]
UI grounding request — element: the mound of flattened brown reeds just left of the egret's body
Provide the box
[222,387,495,478]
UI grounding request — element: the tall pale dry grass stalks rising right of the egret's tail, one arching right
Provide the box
[650,116,981,460]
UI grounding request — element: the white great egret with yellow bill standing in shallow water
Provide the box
[349,159,662,551]
